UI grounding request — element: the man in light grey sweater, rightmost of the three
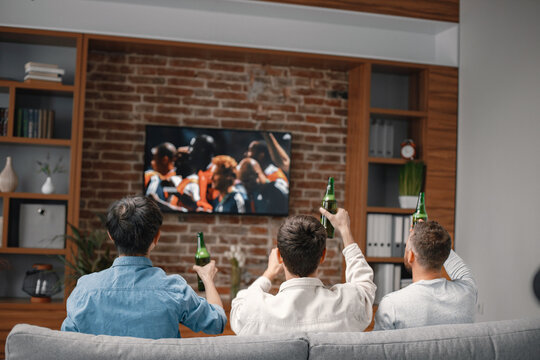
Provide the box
[374,221,477,330]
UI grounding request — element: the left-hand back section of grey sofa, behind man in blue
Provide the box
[6,324,308,360]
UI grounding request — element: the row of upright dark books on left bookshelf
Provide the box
[15,108,54,139]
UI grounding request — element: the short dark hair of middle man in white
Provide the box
[277,215,326,277]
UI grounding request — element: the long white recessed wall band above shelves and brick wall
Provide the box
[0,0,458,66]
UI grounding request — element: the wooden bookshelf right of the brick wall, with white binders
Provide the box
[345,60,458,299]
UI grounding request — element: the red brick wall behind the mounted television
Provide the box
[80,52,348,293]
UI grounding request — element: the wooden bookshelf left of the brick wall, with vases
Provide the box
[0,27,83,316]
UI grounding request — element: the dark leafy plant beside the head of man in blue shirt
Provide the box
[59,214,114,283]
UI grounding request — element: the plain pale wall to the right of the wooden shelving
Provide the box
[456,0,540,321]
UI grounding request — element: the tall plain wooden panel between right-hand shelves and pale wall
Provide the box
[424,67,458,238]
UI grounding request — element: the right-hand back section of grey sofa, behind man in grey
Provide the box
[308,318,540,360]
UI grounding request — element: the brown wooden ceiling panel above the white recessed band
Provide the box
[261,0,459,22]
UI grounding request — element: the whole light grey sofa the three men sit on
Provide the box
[6,318,540,360]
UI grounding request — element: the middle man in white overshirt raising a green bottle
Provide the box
[230,208,376,335]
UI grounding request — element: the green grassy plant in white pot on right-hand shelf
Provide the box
[399,161,424,209]
